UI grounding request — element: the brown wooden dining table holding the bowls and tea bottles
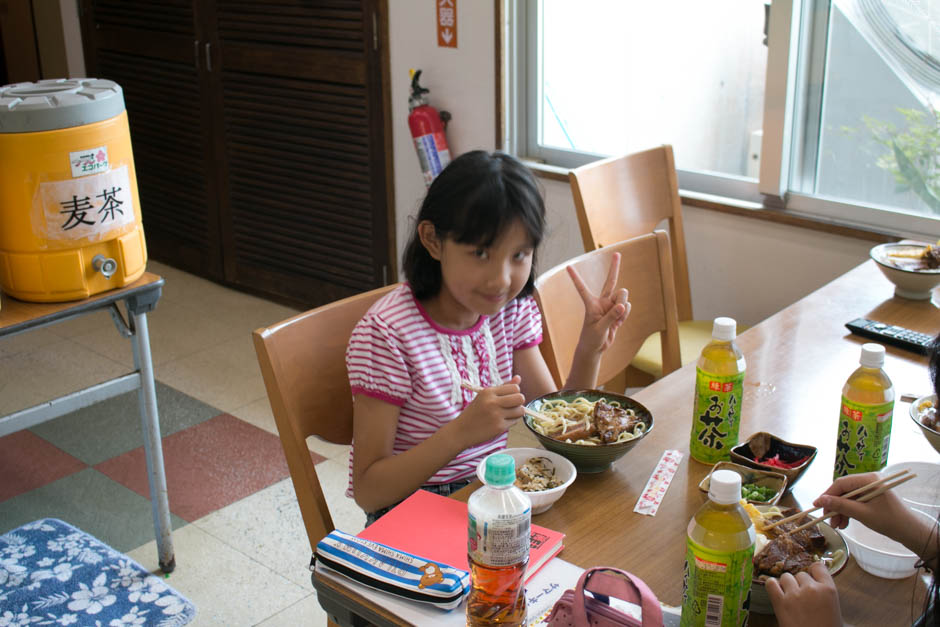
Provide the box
[314,261,940,625]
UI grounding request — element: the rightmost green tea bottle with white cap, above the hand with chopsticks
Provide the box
[832,343,894,478]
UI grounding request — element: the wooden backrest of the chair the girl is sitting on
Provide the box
[252,285,395,550]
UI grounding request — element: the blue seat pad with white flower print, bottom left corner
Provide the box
[0,518,196,627]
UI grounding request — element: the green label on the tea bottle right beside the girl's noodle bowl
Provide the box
[689,368,744,464]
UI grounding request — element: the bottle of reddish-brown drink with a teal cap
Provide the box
[467,454,532,626]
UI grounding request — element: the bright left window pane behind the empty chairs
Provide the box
[540,0,767,178]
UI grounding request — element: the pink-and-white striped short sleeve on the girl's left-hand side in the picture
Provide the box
[346,314,412,407]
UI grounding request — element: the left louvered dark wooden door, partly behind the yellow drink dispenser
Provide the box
[81,0,223,279]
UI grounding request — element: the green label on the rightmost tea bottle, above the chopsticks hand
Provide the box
[832,396,894,479]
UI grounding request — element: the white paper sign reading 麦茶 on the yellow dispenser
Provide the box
[33,166,135,241]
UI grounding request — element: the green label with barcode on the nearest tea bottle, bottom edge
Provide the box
[679,538,754,627]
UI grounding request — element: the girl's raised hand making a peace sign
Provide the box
[567,253,630,354]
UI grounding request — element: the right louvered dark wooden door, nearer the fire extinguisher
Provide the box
[208,0,390,304]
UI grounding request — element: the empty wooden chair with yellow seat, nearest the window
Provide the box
[568,145,712,385]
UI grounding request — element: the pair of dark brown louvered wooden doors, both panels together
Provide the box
[83,0,394,306]
